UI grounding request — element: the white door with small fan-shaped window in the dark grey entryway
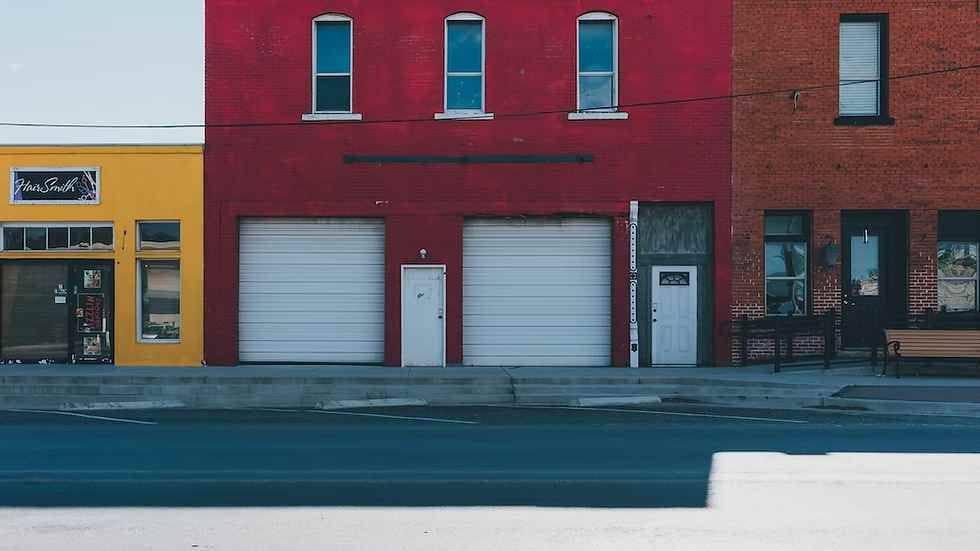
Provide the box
[650,266,698,365]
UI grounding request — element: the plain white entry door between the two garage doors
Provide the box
[402,266,446,367]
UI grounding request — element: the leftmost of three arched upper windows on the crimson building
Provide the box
[313,15,353,113]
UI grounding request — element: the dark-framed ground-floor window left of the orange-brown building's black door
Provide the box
[765,212,810,316]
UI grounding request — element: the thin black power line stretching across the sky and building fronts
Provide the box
[0,64,980,130]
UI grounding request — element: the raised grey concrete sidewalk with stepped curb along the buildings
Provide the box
[0,365,980,417]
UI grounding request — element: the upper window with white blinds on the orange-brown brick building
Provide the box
[837,14,893,124]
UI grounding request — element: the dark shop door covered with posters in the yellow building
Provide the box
[71,262,114,363]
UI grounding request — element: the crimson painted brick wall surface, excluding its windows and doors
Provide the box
[205,0,732,365]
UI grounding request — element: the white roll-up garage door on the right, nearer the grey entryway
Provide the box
[463,218,612,366]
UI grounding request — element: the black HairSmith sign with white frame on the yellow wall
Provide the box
[10,168,102,205]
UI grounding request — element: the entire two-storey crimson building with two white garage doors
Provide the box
[205,0,732,366]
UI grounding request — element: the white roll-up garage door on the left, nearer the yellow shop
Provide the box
[238,218,385,363]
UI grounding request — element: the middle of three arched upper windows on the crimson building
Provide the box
[444,13,486,114]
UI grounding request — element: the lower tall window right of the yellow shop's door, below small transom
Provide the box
[139,260,180,342]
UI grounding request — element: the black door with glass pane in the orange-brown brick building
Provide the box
[841,213,908,348]
